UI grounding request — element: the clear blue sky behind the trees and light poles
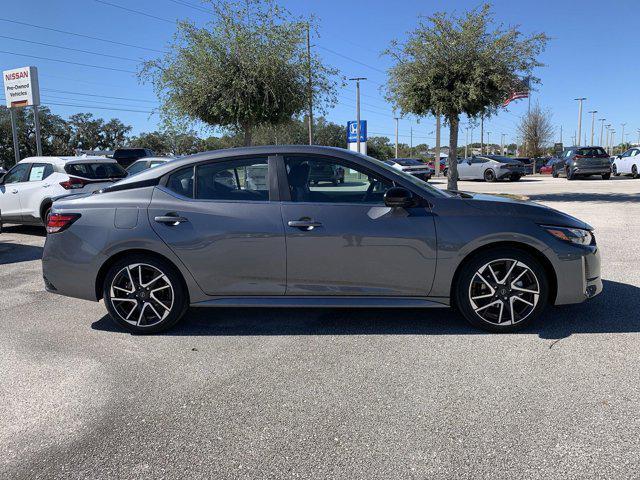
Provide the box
[0,0,640,146]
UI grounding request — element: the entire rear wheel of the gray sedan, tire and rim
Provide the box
[103,255,189,333]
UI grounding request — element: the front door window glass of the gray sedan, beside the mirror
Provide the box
[285,157,393,205]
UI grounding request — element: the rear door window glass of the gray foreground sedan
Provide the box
[195,157,269,202]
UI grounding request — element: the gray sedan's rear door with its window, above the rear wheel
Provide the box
[148,156,286,296]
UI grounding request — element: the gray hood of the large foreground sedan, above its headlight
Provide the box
[463,192,593,230]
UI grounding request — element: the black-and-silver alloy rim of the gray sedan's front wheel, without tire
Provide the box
[469,258,540,325]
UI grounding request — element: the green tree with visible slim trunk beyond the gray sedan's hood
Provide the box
[386,4,548,190]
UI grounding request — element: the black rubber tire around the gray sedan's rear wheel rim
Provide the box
[102,255,189,334]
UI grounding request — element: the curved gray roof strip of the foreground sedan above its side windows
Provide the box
[112,145,362,185]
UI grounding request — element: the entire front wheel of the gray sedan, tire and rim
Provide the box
[454,248,549,332]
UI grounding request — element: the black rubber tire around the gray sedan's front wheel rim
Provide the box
[452,248,549,333]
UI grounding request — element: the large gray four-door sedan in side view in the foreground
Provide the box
[42,146,602,333]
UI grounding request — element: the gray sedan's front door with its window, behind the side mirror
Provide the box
[279,155,436,296]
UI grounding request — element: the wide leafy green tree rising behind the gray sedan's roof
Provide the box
[140,0,336,145]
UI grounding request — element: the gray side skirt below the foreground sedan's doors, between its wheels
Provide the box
[191,295,449,308]
